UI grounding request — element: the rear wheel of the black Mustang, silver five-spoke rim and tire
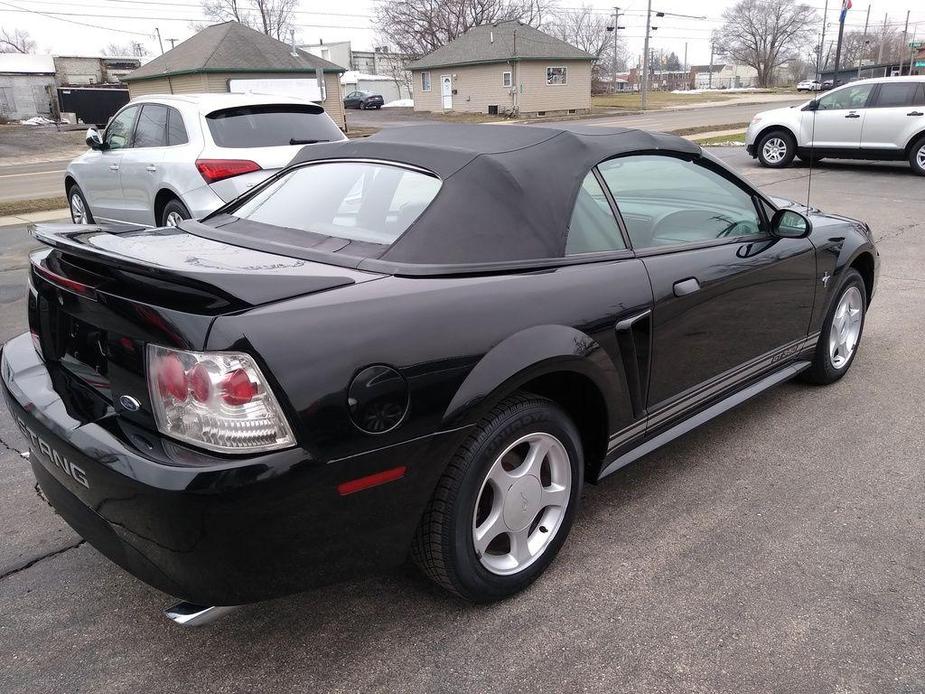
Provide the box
[412,393,584,602]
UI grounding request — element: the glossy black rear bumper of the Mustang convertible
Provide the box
[0,334,460,605]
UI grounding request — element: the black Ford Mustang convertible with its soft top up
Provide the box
[2,126,879,618]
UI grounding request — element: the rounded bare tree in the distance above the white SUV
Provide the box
[717,0,817,87]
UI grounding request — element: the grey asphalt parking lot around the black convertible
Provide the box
[0,148,925,694]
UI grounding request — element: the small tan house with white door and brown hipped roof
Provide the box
[407,21,594,115]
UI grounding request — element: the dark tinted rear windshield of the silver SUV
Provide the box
[206,104,344,148]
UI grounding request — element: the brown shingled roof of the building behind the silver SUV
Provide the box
[123,22,344,82]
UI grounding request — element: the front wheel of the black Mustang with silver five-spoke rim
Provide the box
[803,269,867,385]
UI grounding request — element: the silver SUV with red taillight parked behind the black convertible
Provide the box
[64,94,346,226]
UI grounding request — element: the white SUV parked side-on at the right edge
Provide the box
[745,76,925,176]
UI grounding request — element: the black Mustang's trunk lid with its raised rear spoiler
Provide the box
[29,224,375,309]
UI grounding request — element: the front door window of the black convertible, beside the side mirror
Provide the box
[598,155,763,249]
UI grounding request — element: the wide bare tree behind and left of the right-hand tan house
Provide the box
[375,0,550,60]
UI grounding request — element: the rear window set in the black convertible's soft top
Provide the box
[229,162,441,245]
